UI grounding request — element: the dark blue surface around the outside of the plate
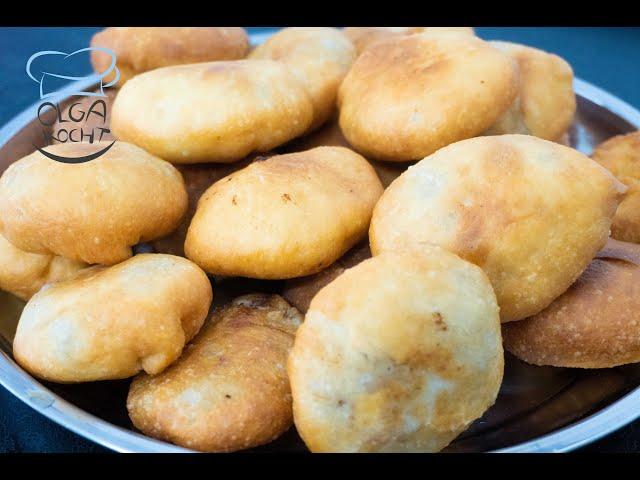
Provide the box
[0,27,640,452]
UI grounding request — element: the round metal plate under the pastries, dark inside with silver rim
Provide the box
[0,31,640,452]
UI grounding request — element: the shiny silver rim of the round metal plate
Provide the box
[0,52,640,453]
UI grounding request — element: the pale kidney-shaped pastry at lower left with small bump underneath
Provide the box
[13,254,212,383]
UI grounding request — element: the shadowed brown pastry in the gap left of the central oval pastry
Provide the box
[150,153,272,257]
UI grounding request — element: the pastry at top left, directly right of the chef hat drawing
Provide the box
[91,27,249,87]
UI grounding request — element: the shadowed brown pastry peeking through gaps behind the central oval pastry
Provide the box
[282,119,410,188]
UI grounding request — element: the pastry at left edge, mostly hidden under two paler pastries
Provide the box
[0,235,87,300]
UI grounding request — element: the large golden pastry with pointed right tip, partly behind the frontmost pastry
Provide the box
[369,135,625,322]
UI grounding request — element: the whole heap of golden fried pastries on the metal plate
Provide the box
[0,27,640,452]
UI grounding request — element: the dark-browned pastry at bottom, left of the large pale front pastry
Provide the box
[127,294,302,452]
